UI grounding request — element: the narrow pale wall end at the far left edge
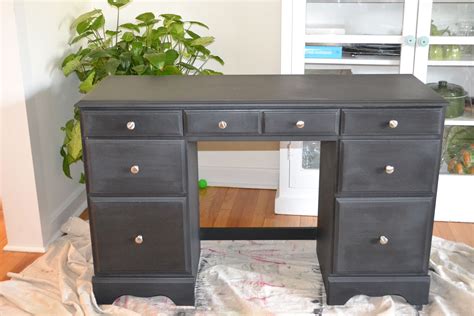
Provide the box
[0,2,43,251]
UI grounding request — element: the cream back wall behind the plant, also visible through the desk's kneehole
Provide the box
[94,0,281,189]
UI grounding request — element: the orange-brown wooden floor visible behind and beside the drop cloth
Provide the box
[0,187,474,280]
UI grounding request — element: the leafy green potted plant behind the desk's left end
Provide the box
[60,0,224,183]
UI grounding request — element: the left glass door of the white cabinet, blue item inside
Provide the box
[282,0,417,74]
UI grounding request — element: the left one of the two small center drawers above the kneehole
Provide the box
[185,110,260,135]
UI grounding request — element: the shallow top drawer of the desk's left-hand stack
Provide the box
[82,111,183,137]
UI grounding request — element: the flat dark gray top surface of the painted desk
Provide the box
[77,75,445,108]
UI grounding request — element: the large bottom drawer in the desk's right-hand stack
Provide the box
[334,198,433,274]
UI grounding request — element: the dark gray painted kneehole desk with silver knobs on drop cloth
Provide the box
[78,75,445,305]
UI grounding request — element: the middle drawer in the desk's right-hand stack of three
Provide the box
[339,139,441,193]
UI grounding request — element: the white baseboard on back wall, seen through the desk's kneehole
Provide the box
[199,166,279,189]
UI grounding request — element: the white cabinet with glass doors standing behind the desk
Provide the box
[275,0,474,222]
